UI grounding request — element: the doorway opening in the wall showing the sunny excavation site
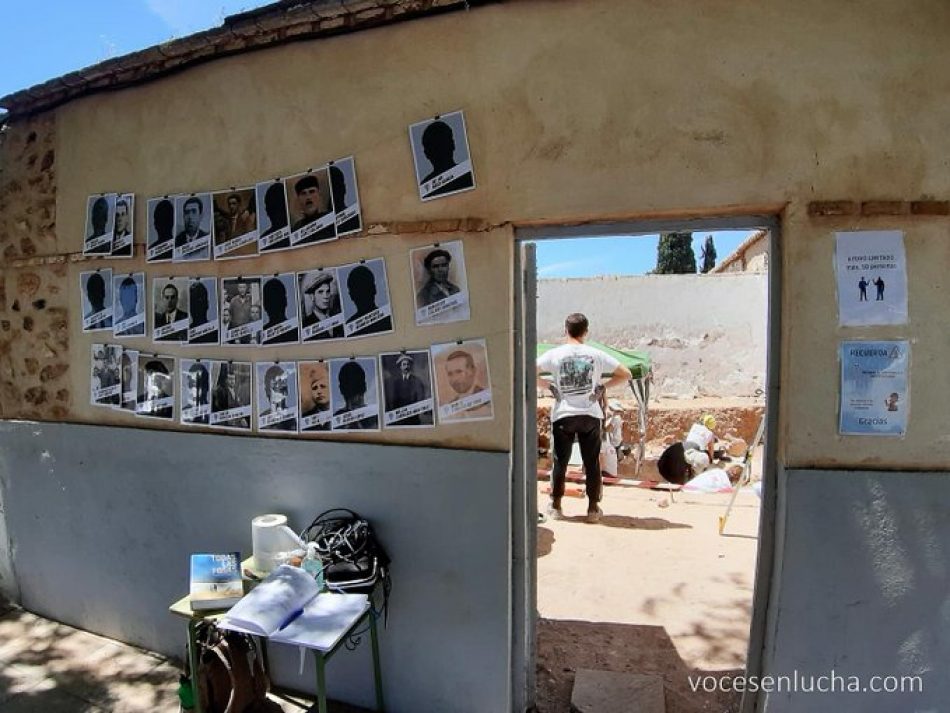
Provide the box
[513,217,779,713]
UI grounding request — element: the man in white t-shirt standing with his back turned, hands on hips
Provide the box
[537,312,632,523]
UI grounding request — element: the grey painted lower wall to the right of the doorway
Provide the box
[765,470,950,713]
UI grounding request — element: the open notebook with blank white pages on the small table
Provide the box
[218,565,369,651]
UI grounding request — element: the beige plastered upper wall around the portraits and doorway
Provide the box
[5,0,950,468]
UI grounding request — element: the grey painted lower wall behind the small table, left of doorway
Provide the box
[0,422,511,713]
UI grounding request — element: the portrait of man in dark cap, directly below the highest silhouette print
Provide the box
[409,240,471,326]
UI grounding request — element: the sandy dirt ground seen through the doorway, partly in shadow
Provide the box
[537,482,759,713]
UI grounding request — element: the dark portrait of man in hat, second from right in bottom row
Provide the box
[379,350,435,428]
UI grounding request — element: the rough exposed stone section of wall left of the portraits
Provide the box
[0,115,71,420]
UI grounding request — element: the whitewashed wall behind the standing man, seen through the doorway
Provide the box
[537,274,768,398]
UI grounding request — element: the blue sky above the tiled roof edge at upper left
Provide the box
[0,0,270,96]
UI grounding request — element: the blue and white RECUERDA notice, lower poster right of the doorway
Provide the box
[838,341,910,436]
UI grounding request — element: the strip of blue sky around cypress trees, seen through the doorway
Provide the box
[537,230,755,278]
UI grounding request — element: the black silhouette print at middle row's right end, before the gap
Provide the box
[337,257,393,337]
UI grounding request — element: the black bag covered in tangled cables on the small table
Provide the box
[300,508,392,612]
